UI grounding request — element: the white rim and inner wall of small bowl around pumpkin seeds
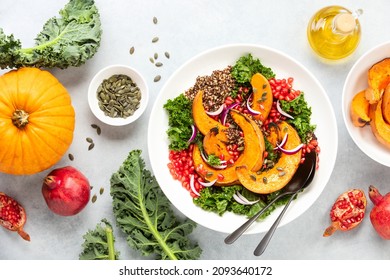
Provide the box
[88,65,149,126]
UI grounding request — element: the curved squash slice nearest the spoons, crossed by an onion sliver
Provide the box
[236,122,302,194]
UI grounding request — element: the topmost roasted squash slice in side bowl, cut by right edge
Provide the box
[365,57,390,104]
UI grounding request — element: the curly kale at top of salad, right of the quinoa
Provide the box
[231,54,275,85]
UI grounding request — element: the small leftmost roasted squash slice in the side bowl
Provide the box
[350,90,371,127]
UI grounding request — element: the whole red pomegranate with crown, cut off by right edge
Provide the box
[368,185,390,239]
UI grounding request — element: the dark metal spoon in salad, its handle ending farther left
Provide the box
[225,152,316,244]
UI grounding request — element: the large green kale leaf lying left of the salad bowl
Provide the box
[110,150,202,260]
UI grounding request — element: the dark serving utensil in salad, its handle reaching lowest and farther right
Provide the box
[253,152,317,256]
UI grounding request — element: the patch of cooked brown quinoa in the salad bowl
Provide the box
[184,65,236,112]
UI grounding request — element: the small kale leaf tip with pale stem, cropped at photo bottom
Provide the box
[79,219,119,260]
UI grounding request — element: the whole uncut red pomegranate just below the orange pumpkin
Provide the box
[42,166,91,216]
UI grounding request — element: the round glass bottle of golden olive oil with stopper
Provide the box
[307,6,361,60]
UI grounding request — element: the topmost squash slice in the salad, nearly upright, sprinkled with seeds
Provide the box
[251,73,273,121]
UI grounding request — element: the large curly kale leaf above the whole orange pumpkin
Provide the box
[0,0,102,69]
